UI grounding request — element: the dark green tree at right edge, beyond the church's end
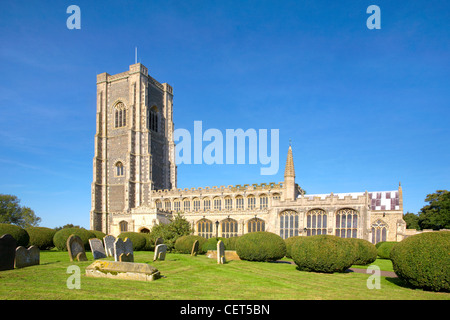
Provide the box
[419,190,450,230]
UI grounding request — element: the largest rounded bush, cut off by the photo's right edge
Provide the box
[390,231,450,291]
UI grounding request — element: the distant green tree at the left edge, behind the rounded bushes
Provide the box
[0,194,41,228]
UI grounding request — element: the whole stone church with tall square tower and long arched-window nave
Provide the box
[90,63,406,244]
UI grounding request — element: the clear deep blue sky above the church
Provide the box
[0,0,450,228]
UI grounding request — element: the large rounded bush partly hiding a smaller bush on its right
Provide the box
[291,235,355,273]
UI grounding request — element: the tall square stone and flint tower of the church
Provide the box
[90,63,177,233]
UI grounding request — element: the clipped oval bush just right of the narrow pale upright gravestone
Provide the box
[236,231,286,261]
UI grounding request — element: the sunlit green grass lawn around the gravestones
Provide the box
[0,251,450,300]
